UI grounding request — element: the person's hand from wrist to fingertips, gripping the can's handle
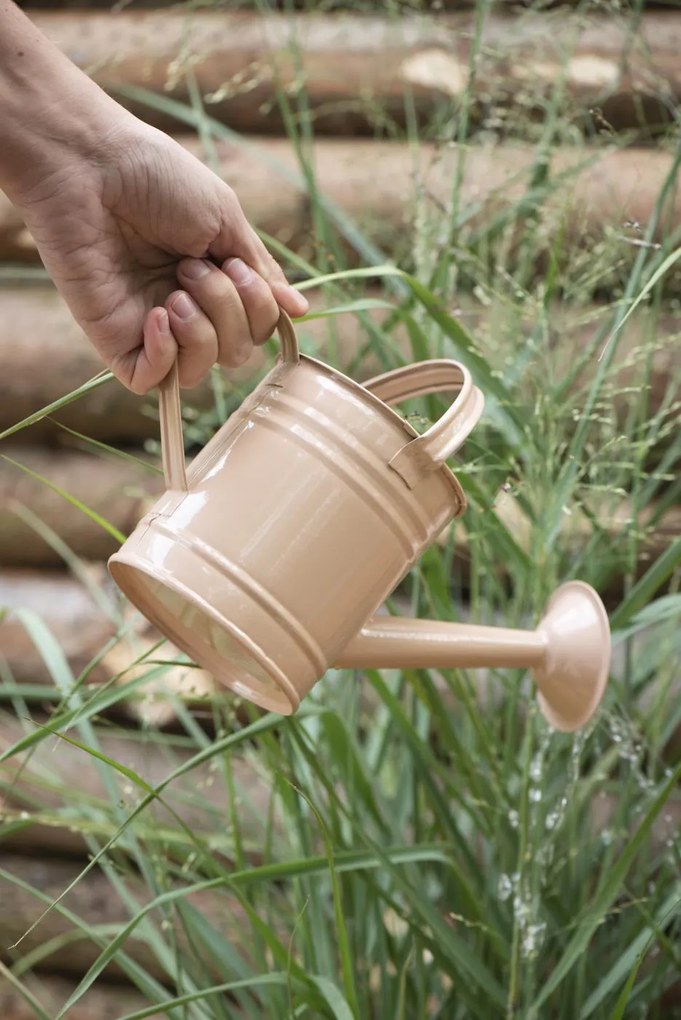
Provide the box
[13,116,308,394]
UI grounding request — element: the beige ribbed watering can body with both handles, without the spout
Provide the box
[110,314,482,713]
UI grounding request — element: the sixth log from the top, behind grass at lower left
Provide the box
[0,713,279,860]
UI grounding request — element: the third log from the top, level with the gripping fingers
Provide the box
[0,288,681,465]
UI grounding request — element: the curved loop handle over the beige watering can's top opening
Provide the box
[363,358,484,489]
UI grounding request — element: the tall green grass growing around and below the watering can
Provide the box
[0,3,681,1020]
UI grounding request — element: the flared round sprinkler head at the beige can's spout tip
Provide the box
[534,580,611,733]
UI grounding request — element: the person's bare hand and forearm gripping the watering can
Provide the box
[0,0,308,394]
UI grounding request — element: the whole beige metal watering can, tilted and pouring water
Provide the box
[109,313,610,730]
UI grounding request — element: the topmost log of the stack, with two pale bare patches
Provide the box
[32,8,681,135]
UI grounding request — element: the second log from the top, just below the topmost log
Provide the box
[0,136,681,279]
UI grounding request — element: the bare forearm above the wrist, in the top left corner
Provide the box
[0,0,122,199]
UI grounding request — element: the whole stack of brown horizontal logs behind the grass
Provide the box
[0,0,681,1020]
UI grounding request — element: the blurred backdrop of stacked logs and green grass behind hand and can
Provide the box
[0,0,681,1020]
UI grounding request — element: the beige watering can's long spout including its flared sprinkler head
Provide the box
[335,581,611,732]
